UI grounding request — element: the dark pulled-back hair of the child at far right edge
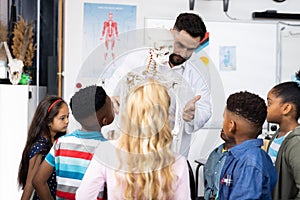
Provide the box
[272,70,300,120]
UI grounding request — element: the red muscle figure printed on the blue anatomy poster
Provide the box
[100,12,118,60]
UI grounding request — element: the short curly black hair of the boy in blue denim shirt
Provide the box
[226,91,267,128]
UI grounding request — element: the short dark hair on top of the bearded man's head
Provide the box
[174,13,206,39]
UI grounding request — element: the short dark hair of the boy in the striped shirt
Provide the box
[70,85,107,122]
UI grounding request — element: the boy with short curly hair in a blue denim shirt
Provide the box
[218,91,277,200]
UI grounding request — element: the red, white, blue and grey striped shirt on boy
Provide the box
[45,130,106,199]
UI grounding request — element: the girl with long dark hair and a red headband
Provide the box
[18,96,69,199]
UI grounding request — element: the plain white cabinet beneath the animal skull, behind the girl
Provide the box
[0,84,46,199]
